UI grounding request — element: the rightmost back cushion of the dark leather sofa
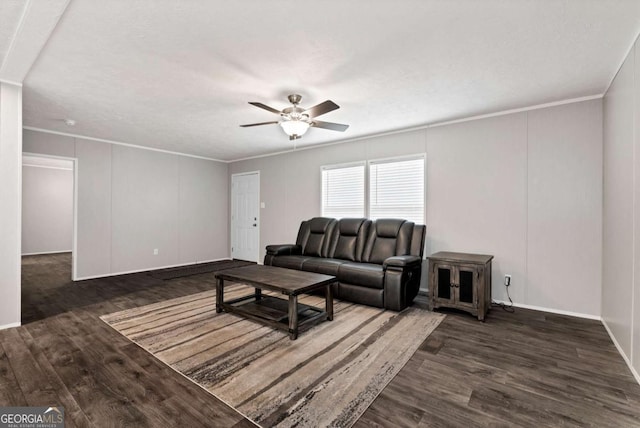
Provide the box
[362,218,414,264]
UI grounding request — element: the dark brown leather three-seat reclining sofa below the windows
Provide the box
[264,217,425,311]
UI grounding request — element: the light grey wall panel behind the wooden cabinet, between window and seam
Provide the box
[426,113,529,303]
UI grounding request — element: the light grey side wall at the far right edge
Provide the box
[602,36,640,381]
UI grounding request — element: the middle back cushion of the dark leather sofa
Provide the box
[329,218,371,262]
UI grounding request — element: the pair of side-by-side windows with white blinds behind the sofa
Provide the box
[322,155,424,224]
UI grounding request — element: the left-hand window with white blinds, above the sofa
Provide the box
[322,163,365,218]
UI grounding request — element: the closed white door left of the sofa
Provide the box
[231,172,260,262]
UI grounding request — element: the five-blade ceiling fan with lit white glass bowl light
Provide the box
[240,94,349,140]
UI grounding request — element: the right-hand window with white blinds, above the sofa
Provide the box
[369,157,424,224]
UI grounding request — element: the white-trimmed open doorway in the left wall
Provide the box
[22,153,77,281]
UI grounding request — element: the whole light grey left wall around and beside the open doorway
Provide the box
[24,130,229,279]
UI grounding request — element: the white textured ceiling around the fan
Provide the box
[10,0,640,160]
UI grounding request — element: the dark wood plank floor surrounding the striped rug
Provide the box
[0,254,640,427]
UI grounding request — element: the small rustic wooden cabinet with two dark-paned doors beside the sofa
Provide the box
[428,251,493,321]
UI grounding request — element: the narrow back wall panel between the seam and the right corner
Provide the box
[526,100,602,315]
